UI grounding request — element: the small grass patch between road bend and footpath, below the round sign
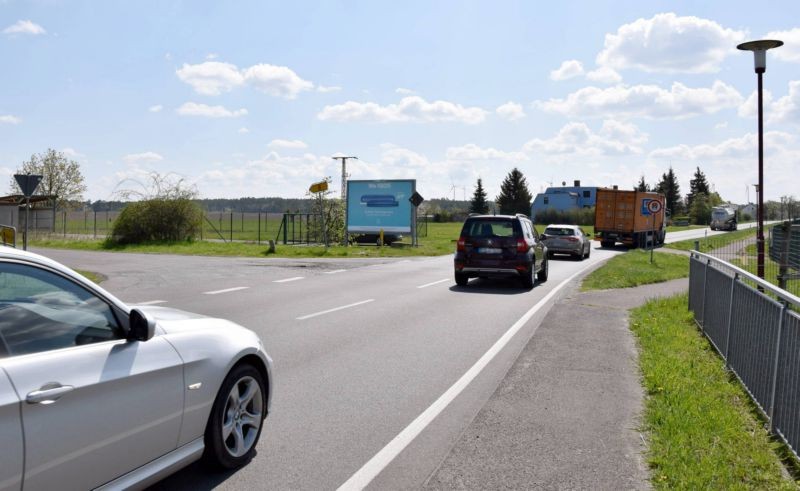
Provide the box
[581,249,689,291]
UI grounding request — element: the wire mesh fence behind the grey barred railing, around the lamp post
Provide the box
[698,221,800,296]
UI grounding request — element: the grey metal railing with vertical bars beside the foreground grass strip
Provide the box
[689,251,800,455]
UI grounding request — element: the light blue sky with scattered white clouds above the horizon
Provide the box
[0,0,800,203]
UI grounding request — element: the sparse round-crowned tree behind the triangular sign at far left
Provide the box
[11,148,86,225]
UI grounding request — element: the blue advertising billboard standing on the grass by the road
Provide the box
[347,179,416,234]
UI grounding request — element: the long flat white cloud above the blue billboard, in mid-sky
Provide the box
[317,96,487,124]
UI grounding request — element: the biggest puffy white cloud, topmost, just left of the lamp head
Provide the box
[597,12,746,73]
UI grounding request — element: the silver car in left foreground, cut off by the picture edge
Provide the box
[0,246,273,490]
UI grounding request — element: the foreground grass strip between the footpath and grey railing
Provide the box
[630,294,797,489]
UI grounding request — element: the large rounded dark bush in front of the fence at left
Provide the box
[108,198,202,244]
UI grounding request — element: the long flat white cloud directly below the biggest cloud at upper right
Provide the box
[534,80,742,119]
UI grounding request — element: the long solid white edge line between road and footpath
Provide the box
[339,270,584,491]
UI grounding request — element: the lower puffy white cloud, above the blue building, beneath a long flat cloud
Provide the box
[523,120,647,156]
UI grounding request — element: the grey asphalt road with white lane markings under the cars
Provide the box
[36,243,623,490]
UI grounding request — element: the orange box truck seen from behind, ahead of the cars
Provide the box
[594,188,667,247]
